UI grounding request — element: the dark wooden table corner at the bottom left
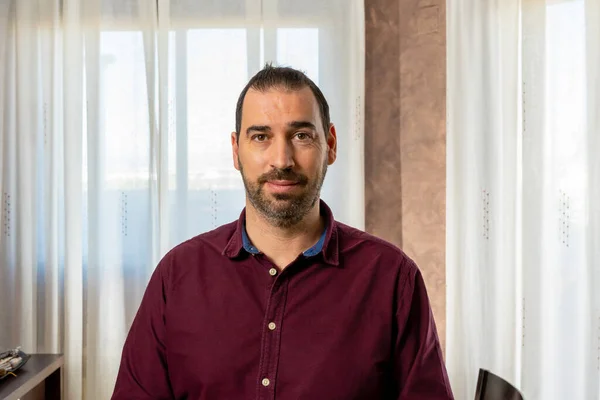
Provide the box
[0,354,64,400]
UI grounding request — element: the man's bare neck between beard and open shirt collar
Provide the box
[246,201,325,269]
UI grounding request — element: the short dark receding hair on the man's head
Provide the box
[235,64,330,139]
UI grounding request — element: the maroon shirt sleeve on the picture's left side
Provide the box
[112,259,174,400]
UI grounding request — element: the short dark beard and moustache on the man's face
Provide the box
[238,157,327,228]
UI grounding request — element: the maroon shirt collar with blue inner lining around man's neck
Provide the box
[223,200,339,265]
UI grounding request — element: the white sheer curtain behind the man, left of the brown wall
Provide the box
[0,0,364,399]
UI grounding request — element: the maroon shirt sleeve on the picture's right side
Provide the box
[394,260,454,400]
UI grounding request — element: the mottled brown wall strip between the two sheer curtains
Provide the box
[365,0,446,346]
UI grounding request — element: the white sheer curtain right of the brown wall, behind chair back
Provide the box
[447,0,600,400]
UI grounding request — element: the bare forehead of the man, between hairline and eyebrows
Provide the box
[242,87,321,127]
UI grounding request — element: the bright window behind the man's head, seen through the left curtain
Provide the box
[88,26,319,250]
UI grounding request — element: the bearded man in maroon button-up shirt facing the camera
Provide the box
[113,65,453,400]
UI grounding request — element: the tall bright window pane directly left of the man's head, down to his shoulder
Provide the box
[185,29,248,237]
